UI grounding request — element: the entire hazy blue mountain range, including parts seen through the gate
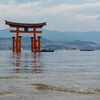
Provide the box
[0,29,100,43]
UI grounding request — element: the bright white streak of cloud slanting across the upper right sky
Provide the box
[43,2,100,13]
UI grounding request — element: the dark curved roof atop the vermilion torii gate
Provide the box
[5,20,46,28]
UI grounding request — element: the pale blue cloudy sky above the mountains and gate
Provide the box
[0,0,100,32]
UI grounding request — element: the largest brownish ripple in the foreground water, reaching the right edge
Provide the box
[27,84,100,94]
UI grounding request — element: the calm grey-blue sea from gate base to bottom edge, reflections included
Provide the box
[0,50,100,100]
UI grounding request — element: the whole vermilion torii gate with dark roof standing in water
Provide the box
[5,20,46,52]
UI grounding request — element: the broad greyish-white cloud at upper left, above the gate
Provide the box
[0,2,40,17]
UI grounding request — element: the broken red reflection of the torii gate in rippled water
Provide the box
[12,52,42,73]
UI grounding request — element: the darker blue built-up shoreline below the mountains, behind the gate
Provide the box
[0,37,100,50]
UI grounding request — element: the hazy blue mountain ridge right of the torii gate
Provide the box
[42,30,100,43]
